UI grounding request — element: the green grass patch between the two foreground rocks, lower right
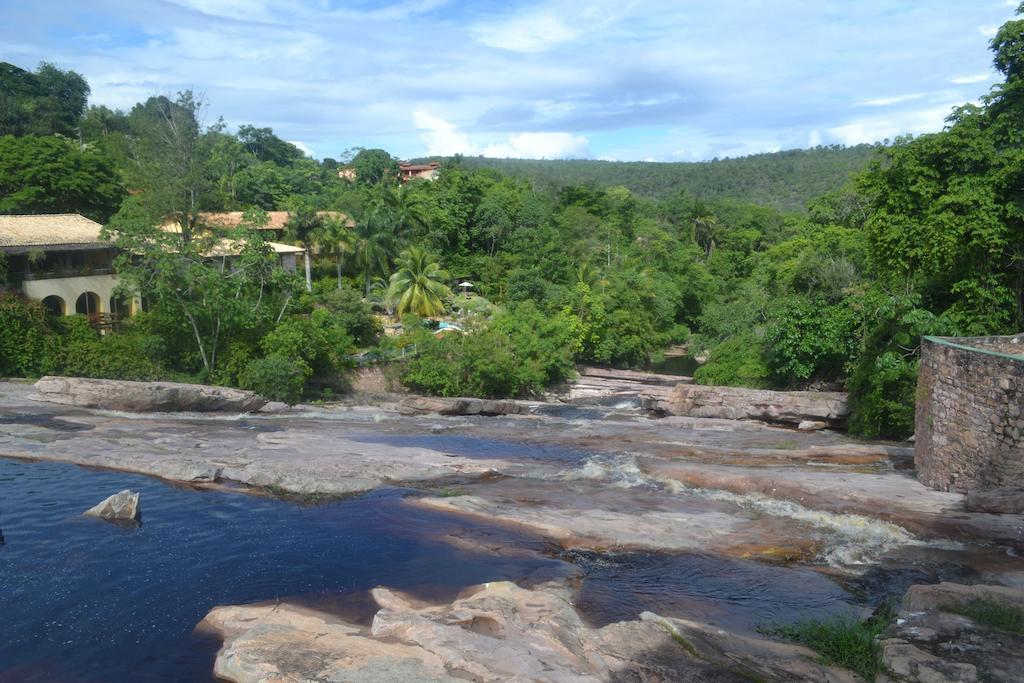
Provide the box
[758,603,896,681]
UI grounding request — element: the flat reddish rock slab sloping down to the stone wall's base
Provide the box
[640,458,1024,548]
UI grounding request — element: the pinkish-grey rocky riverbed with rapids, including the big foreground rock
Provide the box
[0,383,1024,681]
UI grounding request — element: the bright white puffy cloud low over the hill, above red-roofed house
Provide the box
[413,111,590,159]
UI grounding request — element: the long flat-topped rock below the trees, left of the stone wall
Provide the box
[664,384,850,427]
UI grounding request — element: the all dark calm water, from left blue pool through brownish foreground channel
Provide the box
[0,454,864,681]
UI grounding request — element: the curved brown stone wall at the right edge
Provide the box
[914,335,1024,493]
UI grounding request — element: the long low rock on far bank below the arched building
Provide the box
[30,377,267,413]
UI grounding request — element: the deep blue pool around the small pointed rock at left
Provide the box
[0,459,571,681]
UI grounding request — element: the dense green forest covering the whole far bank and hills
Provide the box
[0,5,1024,436]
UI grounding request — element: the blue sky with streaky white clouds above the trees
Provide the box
[0,0,1017,161]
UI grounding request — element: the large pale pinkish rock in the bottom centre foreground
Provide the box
[200,582,855,683]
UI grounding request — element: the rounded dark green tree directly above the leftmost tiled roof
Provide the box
[0,135,125,222]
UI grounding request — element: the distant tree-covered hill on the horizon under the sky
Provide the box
[415,144,879,211]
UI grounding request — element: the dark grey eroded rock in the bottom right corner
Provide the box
[879,583,1024,683]
